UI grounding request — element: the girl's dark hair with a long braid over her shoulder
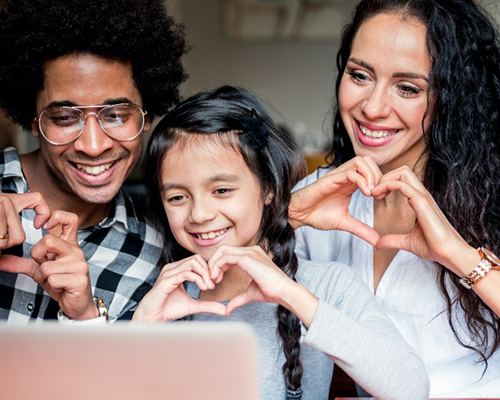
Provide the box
[146,86,305,391]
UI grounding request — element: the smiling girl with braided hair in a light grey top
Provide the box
[133,87,428,399]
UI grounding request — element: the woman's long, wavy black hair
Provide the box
[329,0,500,364]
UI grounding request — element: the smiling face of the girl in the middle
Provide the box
[161,134,263,260]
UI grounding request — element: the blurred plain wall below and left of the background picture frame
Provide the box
[172,0,341,151]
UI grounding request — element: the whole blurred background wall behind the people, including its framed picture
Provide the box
[0,0,500,153]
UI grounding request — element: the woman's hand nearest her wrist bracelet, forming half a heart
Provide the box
[372,166,480,276]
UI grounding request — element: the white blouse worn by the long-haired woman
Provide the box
[296,169,500,397]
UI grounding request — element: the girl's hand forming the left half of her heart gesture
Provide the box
[132,255,226,322]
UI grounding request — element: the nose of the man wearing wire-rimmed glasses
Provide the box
[74,112,114,157]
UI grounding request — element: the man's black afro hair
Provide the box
[0,0,186,130]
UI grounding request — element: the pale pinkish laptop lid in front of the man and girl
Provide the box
[0,322,259,400]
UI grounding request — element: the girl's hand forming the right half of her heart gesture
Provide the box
[208,246,318,326]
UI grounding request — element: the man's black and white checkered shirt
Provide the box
[0,148,161,323]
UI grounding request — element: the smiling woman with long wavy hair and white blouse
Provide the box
[290,0,500,397]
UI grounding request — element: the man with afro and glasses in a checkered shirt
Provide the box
[0,0,186,323]
